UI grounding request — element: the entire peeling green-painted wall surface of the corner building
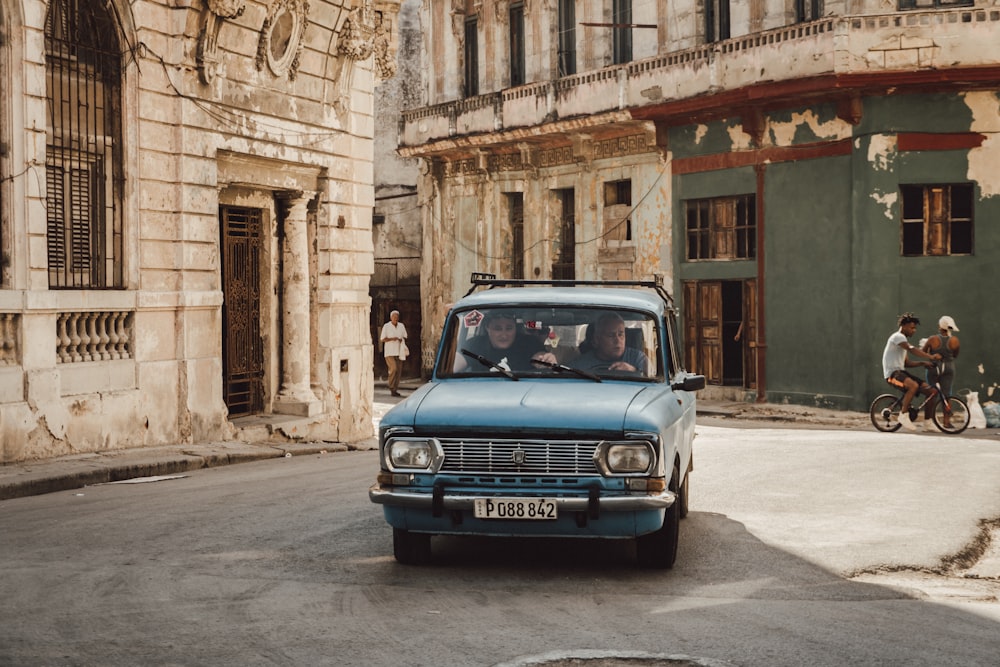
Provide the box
[669,95,1000,410]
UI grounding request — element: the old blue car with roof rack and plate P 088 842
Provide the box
[369,274,705,568]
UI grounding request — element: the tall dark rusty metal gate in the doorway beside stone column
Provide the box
[219,206,264,418]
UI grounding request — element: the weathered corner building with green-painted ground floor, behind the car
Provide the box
[400,0,1000,409]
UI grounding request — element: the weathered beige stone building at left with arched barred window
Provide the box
[0,0,399,462]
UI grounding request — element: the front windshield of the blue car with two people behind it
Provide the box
[437,306,663,381]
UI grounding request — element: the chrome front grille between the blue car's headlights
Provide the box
[439,439,600,475]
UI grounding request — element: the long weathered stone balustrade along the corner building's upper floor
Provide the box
[399,8,1000,152]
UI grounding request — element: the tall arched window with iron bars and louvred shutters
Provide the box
[45,0,124,289]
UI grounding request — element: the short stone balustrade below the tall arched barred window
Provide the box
[56,311,133,364]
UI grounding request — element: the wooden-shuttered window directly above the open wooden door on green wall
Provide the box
[684,195,757,260]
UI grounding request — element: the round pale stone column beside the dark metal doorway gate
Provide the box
[274,192,323,417]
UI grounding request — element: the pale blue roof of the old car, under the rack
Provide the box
[453,286,667,317]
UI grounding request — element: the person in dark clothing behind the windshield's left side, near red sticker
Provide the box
[454,312,556,373]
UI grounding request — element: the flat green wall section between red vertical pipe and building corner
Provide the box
[762,158,854,406]
